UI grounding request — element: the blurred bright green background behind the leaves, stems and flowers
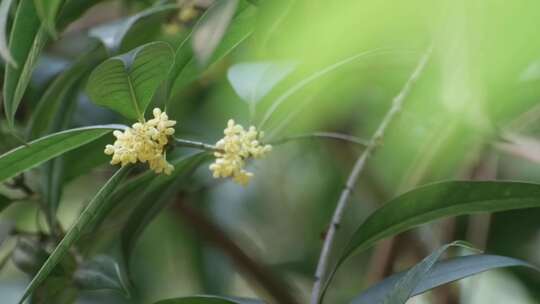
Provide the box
[0,0,540,303]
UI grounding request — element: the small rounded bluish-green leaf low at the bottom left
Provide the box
[73,255,129,296]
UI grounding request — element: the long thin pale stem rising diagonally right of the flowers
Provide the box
[311,47,431,304]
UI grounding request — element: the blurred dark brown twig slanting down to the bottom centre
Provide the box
[174,197,298,304]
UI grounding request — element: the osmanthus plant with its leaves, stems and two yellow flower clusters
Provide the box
[0,0,540,304]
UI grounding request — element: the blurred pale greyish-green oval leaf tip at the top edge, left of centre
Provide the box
[192,0,238,65]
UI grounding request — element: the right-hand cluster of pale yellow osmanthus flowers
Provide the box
[210,119,272,186]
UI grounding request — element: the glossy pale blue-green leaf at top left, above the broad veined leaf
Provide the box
[89,4,178,52]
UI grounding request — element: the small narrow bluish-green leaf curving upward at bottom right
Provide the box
[382,241,468,304]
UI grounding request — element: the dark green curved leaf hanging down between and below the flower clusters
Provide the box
[121,152,210,269]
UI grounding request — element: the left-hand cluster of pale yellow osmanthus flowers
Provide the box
[105,108,176,175]
